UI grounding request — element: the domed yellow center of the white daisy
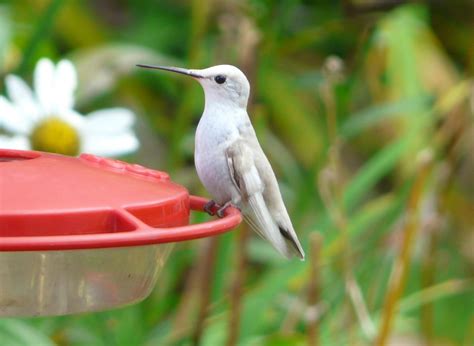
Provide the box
[30,116,80,156]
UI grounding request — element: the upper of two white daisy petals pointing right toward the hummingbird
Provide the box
[84,108,135,134]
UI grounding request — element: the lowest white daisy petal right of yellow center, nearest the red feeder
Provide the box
[82,131,140,157]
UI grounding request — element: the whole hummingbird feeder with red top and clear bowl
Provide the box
[0,149,241,316]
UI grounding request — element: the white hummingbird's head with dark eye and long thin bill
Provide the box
[137,65,250,108]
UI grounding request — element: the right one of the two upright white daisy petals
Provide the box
[54,60,77,112]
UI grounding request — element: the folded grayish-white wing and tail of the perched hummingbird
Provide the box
[226,139,304,258]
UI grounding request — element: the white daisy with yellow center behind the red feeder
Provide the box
[0,59,139,156]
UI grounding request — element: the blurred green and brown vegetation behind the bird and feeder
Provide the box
[0,0,474,345]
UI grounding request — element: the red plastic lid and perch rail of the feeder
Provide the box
[0,149,241,251]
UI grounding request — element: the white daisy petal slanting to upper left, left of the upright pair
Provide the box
[5,75,40,121]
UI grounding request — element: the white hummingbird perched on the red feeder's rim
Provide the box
[137,64,304,260]
